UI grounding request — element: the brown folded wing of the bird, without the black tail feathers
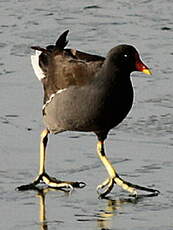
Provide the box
[40,51,104,101]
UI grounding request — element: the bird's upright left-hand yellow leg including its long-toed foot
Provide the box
[17,129,86,191]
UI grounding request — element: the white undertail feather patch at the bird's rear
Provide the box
[31,50,46,81]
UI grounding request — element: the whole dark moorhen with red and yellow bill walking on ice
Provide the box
[18,30,159,197]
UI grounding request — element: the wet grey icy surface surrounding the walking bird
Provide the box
[0,0,173,230]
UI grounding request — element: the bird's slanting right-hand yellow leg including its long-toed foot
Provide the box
[97,141,159,197]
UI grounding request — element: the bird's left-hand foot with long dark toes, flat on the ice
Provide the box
[17,173,86,192]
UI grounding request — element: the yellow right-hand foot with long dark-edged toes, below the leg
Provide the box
[97,175,160,198]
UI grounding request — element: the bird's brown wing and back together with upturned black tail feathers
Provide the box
[32,30,105,103]
